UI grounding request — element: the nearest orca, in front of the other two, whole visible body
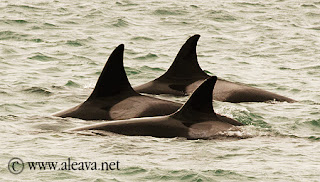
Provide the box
[69,76,243,139]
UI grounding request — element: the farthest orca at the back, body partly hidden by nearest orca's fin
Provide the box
[134,35,295,103]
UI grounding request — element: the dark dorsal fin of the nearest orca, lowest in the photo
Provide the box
[171,76,217,123]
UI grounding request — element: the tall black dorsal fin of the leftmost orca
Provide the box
[89,44,138,99]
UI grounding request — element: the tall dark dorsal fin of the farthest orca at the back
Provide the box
[159,34,208,79]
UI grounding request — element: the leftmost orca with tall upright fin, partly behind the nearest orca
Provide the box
[54,44,181,120]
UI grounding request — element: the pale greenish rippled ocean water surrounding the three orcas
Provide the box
[0,0,320,182]
